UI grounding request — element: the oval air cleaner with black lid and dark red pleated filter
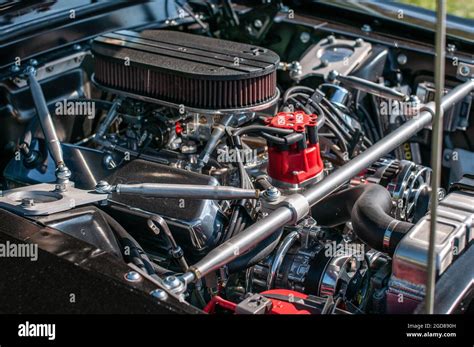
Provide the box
[92,30,279,110]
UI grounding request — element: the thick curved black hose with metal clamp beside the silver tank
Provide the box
[311,184,413,255]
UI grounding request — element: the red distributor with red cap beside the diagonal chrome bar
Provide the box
[267,111,324,185]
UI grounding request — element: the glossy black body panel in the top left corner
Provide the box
[0,1,177,69]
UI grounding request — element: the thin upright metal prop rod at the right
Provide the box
[425,0,446,314]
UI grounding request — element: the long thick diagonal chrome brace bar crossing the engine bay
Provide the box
[180,80,474,284]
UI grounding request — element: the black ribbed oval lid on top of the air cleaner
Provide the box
[92,30,280,80]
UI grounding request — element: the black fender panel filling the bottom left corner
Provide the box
[0,210,200,314]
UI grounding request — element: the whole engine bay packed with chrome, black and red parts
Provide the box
[0,1,474,314]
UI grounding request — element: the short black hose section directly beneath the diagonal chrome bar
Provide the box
[227,229,283,273]
